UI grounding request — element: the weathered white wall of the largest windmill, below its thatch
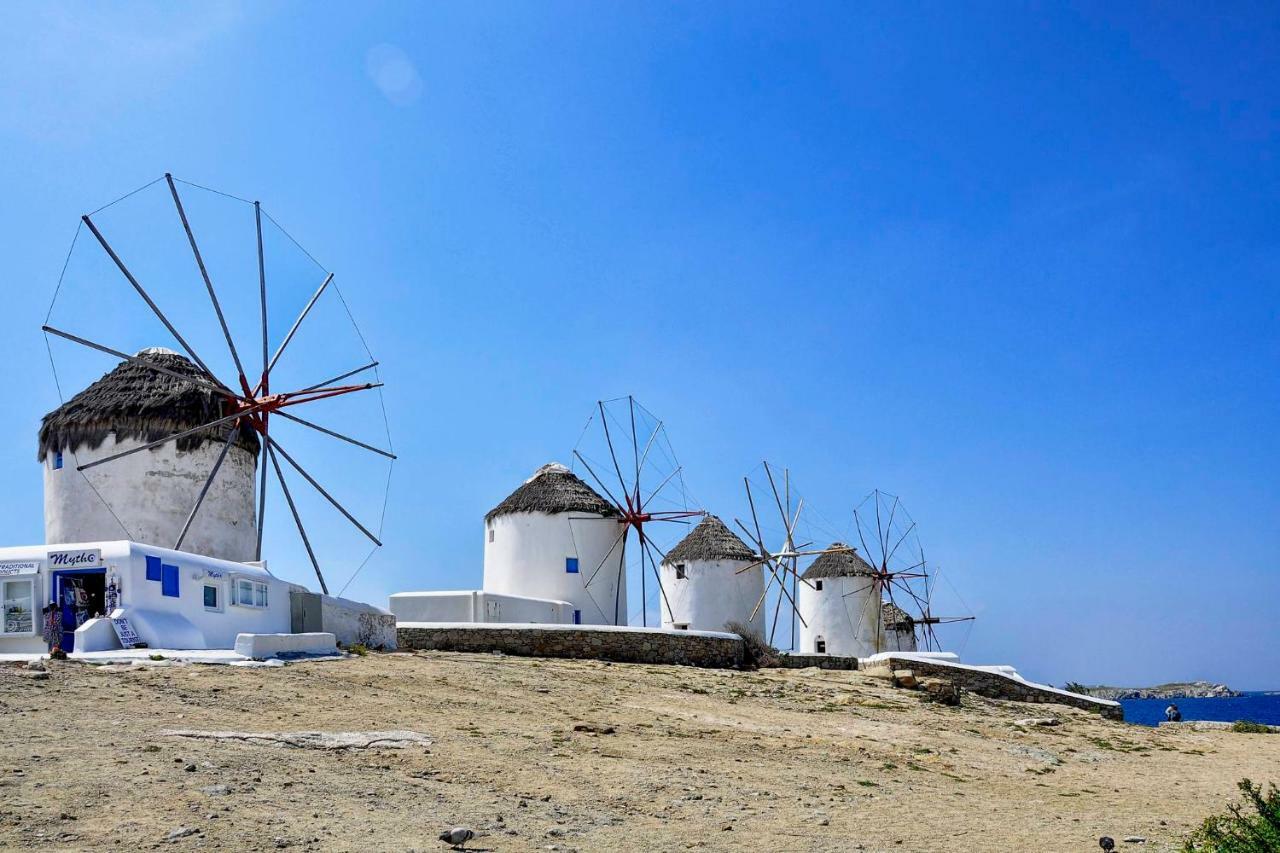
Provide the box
[44,435,257,562]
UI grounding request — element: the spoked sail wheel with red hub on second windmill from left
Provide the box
[572,394,707,626]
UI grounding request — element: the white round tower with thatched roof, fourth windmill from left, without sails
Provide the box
[796,542,883,657]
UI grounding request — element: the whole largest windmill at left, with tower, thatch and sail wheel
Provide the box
[40,174,396,593]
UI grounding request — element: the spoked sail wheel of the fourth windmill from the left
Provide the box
[854,489,974,651]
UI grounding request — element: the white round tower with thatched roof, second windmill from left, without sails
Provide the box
[483,462,627,625]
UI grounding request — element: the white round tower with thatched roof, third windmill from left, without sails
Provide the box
[658,515,764,635]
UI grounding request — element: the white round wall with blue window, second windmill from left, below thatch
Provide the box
[484,512,627,625]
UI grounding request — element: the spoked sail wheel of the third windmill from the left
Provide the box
[733,461,842,648]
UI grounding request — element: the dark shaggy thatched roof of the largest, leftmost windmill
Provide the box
[37,347,259,461]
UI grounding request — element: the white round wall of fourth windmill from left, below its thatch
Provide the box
[796,575,883,657]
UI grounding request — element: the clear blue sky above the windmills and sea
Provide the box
[0,3,1280,688]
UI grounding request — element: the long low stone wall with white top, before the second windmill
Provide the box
[396,622,742,669]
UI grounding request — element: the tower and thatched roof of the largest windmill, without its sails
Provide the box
[38,347,261,562]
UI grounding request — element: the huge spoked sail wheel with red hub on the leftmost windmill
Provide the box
[42,174,396,593]
